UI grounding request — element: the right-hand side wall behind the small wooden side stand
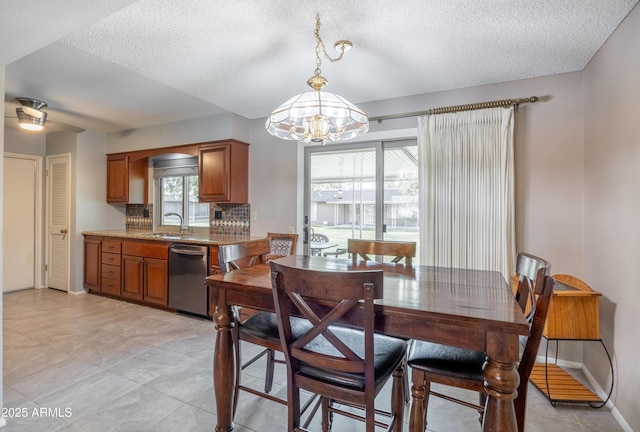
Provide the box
[584,6,640,431]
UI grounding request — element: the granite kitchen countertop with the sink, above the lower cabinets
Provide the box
[82,229,265,245]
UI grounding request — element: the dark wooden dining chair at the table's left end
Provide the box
[218,239,287,412]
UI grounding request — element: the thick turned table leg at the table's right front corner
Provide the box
[482,332,520,432]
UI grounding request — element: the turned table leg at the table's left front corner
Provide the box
[213,306,238,432]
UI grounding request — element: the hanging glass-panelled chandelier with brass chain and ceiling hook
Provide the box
[265,16,369,145]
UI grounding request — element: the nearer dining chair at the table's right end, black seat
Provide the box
[407,274,554,432]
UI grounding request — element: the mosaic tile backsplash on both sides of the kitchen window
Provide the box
[125,204,251,236]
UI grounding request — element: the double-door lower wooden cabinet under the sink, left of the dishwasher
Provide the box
[122,241,169,306]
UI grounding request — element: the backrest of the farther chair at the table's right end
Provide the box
[514,252,551,321]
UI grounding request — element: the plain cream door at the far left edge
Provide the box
[2,154,42,292]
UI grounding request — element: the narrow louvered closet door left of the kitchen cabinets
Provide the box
[47,154,71,291]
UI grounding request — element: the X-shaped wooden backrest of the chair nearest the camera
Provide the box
[271,261,383,392]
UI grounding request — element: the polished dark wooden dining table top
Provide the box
[206,255,529,349]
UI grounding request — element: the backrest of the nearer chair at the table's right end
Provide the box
[518,269,555,384]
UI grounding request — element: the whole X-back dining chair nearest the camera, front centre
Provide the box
[270,261,407,432]
